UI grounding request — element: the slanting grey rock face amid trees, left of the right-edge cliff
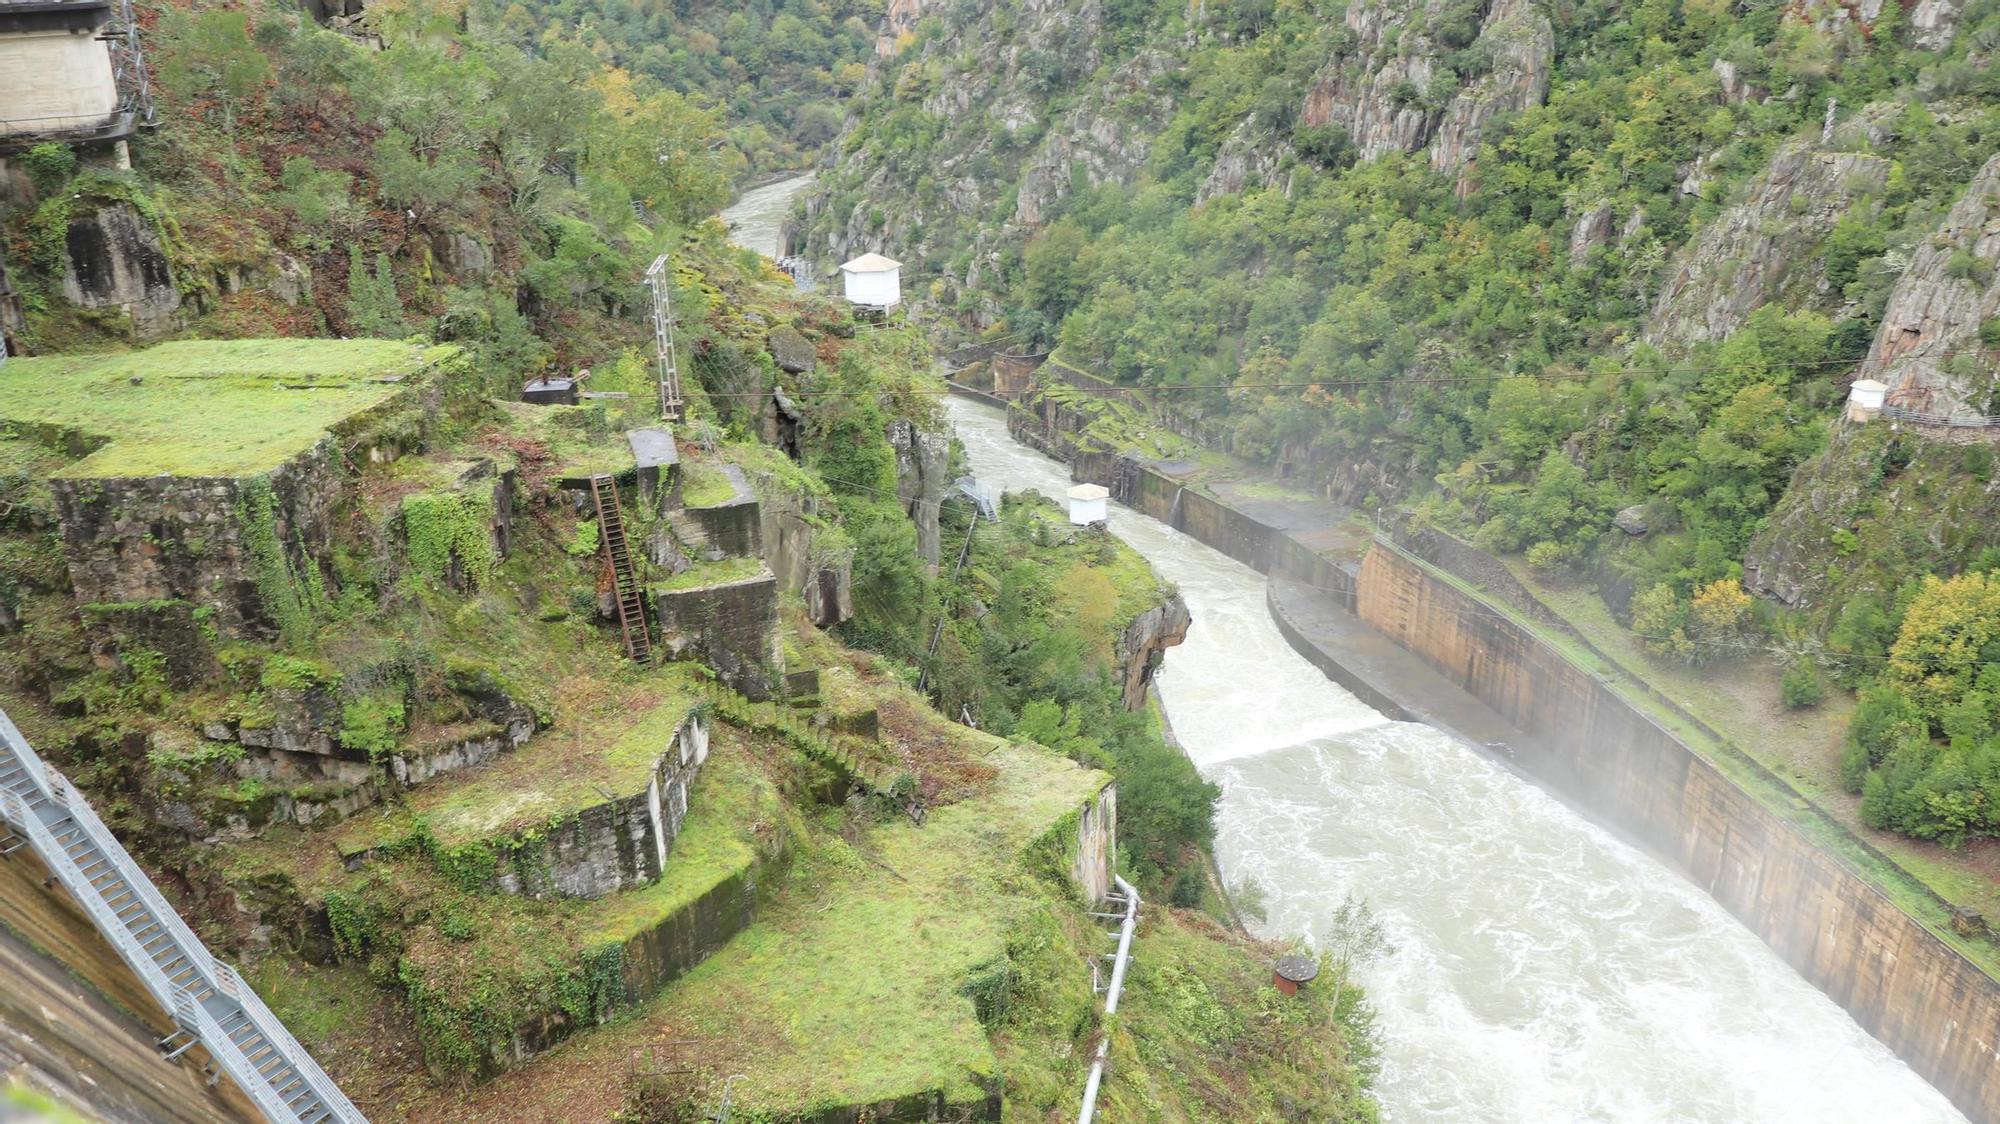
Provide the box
[1640,138,1888,346]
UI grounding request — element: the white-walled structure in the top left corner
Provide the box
[0,0,122,136]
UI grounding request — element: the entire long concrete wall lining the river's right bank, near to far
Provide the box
[980,378,2000,1124]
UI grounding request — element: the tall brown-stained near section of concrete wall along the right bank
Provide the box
[1358,550,2000,1122]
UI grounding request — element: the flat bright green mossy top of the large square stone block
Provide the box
[0,340,458,476]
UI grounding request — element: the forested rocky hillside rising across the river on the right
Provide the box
[814,0,2000,840]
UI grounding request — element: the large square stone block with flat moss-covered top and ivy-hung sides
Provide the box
[0,332,472,634]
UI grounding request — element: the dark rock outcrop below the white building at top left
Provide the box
[62,200,180,340]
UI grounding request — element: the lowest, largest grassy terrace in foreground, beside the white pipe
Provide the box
[390,732,1108,1120]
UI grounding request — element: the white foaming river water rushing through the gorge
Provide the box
[950,398,1964,1124]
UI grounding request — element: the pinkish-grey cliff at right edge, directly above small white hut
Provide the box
[1856,156,2000,414]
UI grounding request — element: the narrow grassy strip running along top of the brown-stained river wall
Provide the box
[1376,528,2000,976]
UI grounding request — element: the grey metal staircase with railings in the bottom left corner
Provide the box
[0,712,366,1124]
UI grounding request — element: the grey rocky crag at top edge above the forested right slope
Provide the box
[1300,0,1556,184]
